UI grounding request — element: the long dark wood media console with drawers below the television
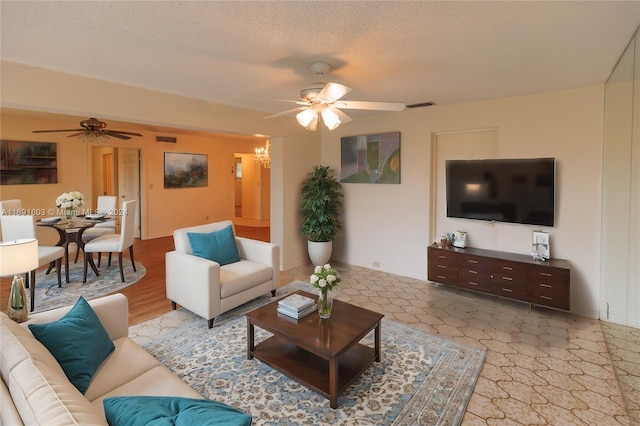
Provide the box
[427,245,571,311]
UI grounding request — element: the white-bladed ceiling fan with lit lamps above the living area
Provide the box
[265,62,405,131]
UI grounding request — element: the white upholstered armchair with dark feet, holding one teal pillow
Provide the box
[165,220,280,328]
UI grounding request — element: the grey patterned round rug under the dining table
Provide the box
[27,256,147,312]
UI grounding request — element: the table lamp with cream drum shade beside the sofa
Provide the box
[0,238,39,322]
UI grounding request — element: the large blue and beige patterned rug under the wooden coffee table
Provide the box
[130,282,485,425]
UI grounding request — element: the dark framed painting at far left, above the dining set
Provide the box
[0,140,58,185]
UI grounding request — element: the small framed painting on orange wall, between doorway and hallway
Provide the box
[164,152,209,188]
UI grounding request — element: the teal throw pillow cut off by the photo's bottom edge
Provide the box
[102,396,251,426]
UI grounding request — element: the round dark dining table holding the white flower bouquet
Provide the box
[36,216,115,283]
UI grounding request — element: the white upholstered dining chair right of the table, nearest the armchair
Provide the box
[82,200,137,283]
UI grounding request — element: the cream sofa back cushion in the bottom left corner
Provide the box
[0,312,107,425]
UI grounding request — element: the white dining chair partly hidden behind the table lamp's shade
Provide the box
[0,215,64,311]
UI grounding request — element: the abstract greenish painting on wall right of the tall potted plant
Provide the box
[340,132,400,184]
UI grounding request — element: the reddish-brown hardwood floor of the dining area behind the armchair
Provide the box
[0,225,270,325]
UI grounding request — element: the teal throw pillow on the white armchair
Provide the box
[187,225,240,265]
